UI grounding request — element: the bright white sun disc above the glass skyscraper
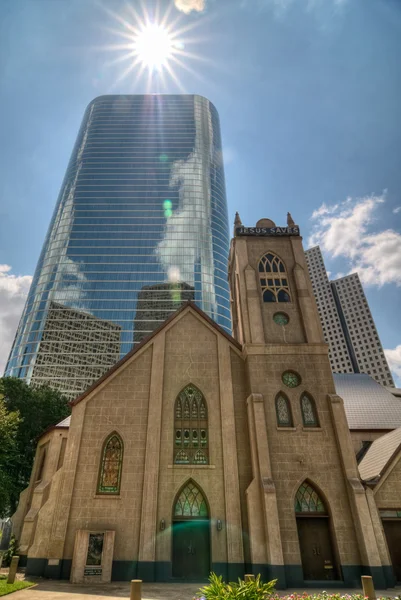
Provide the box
[134,23,174,69]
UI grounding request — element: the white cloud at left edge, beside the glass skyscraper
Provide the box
[0,265,32,375]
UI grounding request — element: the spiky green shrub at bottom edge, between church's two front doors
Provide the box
[194,573,277,600]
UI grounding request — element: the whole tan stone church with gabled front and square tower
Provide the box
[14,215,401,589]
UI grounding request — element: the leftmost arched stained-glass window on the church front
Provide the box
[97,433,124,494]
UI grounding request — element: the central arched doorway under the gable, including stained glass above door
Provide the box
[172,481,210,581]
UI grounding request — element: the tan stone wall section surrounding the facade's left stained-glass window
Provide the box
[64,347,152,561]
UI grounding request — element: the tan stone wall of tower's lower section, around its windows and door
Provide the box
[247,352,361,565]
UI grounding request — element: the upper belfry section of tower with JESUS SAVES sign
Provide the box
[229,213,324,346]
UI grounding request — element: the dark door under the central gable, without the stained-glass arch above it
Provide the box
[173,519,210,581]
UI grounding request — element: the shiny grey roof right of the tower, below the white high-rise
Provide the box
[333,373,401,429]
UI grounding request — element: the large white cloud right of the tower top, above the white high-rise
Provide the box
[309,192,401,286]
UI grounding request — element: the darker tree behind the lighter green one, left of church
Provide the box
[0,377,71,516]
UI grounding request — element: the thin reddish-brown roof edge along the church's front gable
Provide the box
[70,300,242,406]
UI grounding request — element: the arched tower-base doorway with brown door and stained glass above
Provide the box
[295,481,338,581]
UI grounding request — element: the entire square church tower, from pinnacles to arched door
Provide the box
[229,213,384,587]
